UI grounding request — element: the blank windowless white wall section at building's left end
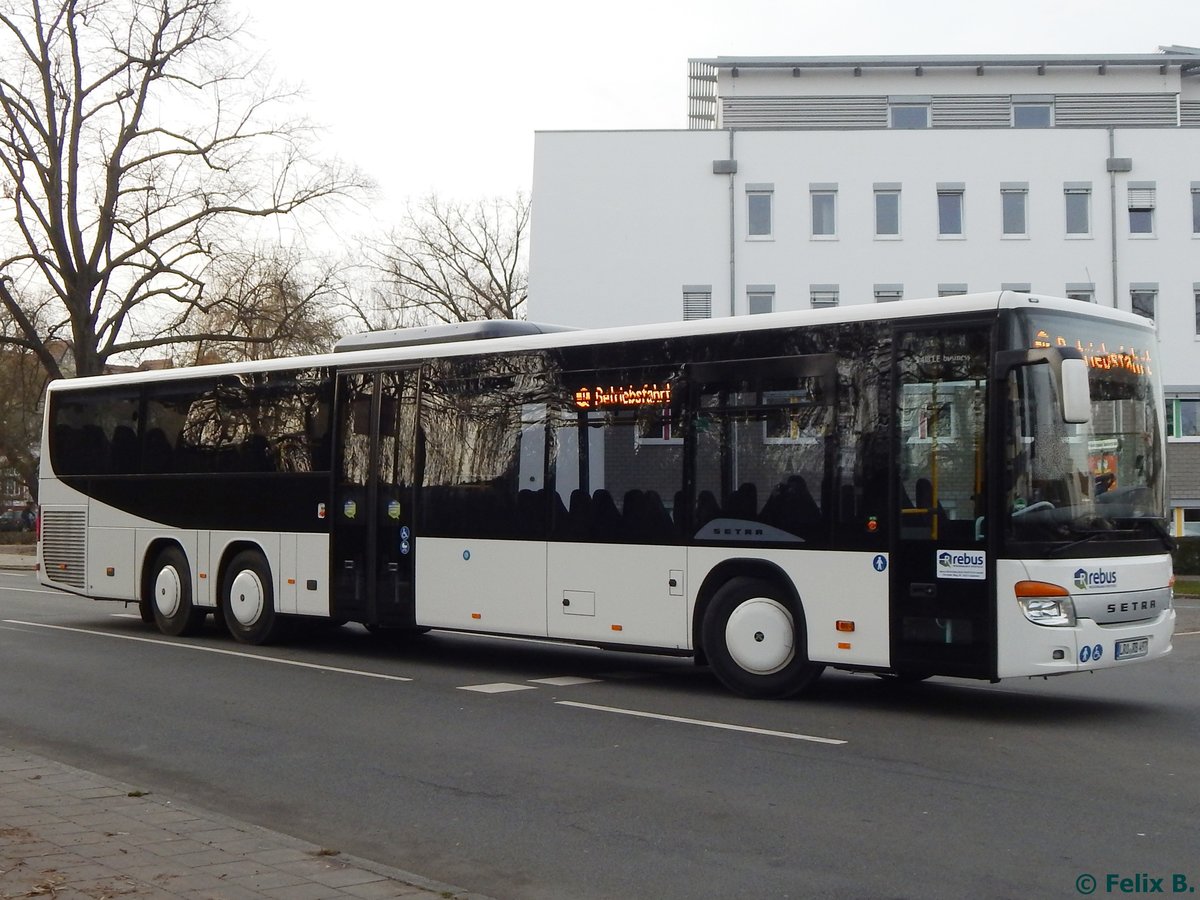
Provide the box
[529,131,730,325]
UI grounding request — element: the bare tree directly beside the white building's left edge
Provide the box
[364,193,529,326]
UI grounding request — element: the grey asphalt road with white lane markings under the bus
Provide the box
[0,575,1200,900]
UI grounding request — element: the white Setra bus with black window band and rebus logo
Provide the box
[40,293,1175,697]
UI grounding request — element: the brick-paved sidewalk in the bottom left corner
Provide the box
[0,746,481,900]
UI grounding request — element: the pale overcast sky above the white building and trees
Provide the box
[230,0,1200,218]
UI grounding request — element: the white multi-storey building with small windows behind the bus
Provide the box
[529,47,1200,533]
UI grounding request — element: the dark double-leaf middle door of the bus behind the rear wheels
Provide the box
[329,368,418,626]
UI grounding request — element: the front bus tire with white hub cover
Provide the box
[701,576,824,700]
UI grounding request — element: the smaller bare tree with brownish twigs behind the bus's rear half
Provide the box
[174,247,349,364]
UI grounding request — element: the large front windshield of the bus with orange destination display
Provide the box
[1003,316,1168,554]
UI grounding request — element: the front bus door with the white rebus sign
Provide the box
[890,324,996,677]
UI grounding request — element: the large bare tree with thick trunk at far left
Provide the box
[0,0,366,377]
